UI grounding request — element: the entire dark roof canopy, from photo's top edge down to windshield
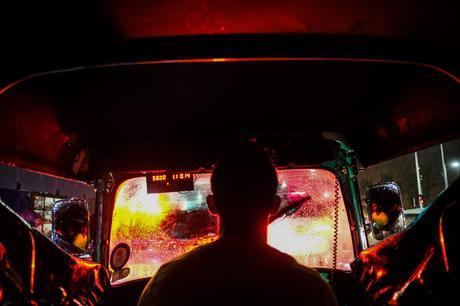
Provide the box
[0,0,460,178]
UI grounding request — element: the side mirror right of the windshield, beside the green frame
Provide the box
[366,182,404,240]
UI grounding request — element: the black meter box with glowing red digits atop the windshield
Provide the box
[146,172,194,193]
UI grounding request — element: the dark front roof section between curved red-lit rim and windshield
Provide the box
[0,58,460,179]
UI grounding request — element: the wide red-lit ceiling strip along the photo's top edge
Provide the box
[106,0,432,38]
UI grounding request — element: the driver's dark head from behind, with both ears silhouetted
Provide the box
[208,143,280,222]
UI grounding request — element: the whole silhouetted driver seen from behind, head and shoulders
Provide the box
[138,143,337,306]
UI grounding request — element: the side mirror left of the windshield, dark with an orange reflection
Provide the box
[51,198,89,257]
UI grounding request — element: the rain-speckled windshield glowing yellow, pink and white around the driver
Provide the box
[110,169,354,284]
